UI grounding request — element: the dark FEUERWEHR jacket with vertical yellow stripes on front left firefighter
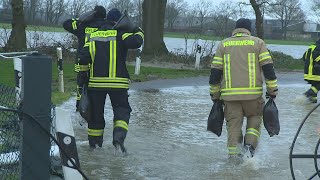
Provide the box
[79,22,144,89]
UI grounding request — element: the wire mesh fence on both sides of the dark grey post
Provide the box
[0,83,63,180]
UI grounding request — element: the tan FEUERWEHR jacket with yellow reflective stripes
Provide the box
[211,28,277,101]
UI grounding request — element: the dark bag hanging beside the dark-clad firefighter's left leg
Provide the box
[79,85,91,122]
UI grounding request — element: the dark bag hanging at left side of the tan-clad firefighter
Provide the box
[207,100,224,137]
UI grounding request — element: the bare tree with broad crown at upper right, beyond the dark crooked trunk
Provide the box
[268,0,305,39]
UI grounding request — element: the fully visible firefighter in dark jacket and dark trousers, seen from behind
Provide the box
[79,9,144,153]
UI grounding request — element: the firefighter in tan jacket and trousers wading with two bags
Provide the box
[209,18,278,157]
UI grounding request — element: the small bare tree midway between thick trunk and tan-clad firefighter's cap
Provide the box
[195,0,212,32]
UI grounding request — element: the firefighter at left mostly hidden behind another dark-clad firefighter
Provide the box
[63,6,106,111]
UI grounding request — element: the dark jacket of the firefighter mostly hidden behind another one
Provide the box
[63,18,106,72]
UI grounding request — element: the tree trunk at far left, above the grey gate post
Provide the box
[4,0,27,52]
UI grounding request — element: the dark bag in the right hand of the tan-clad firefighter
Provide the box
[263,97,280,137]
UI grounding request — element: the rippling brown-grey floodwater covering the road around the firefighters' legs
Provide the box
[61,72,320,180]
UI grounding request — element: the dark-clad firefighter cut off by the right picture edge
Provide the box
[302,39,320,103]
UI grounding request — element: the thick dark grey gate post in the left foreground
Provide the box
[20,53,52,179]
